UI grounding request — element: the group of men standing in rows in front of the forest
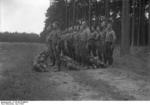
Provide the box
[46,21,116,70]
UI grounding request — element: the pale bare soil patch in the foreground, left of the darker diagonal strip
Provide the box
[45,72,104,100]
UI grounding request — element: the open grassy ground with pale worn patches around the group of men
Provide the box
[0,43,150,100]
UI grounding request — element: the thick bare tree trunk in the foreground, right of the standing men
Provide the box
[120,0,130,55]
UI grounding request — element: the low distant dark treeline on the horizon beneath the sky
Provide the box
[0,32,41,43]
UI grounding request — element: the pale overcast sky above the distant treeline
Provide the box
[0,0,50,33]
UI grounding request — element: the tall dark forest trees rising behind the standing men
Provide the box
[41,0,150,55]
